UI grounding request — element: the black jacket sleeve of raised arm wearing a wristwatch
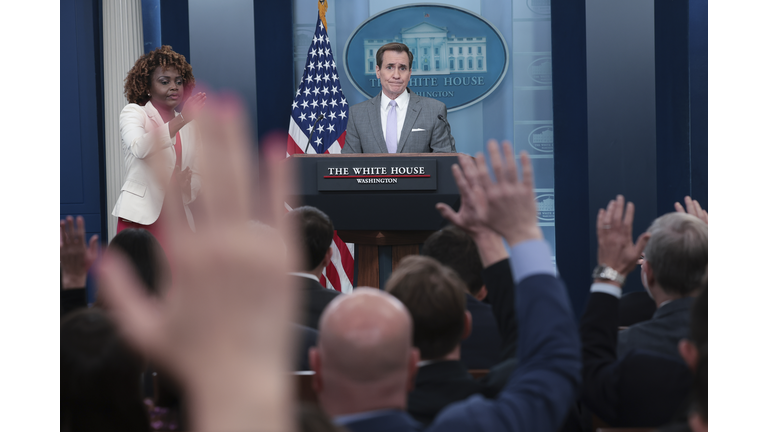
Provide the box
[581,292,692,427]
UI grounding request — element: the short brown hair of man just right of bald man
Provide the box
[386,255,466,360]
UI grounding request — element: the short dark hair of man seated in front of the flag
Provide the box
[286,206,333,270]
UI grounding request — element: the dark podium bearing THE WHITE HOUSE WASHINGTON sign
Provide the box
[286,153,461,231]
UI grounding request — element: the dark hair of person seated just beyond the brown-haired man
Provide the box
[421,225,483,295]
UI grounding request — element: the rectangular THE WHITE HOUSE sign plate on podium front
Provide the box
[317,157,437,191]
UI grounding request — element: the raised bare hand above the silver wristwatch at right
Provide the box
[597,195,651,277]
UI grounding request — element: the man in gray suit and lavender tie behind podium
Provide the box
[341,42,456,153]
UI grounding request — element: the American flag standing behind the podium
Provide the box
[287,9,355,293]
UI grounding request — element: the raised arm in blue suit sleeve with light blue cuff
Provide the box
[433,141,581,432]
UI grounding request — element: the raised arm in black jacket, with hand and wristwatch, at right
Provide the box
[581,195,706,427]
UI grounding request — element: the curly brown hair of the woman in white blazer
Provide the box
[124,45,195,106]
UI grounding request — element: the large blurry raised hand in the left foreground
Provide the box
[100,95,296,430]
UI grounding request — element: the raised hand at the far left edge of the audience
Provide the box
[59,216,99,289]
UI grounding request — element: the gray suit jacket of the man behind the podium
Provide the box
[341,89,456,153]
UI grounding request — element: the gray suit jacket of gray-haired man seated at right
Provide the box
[617,297,695,358]
